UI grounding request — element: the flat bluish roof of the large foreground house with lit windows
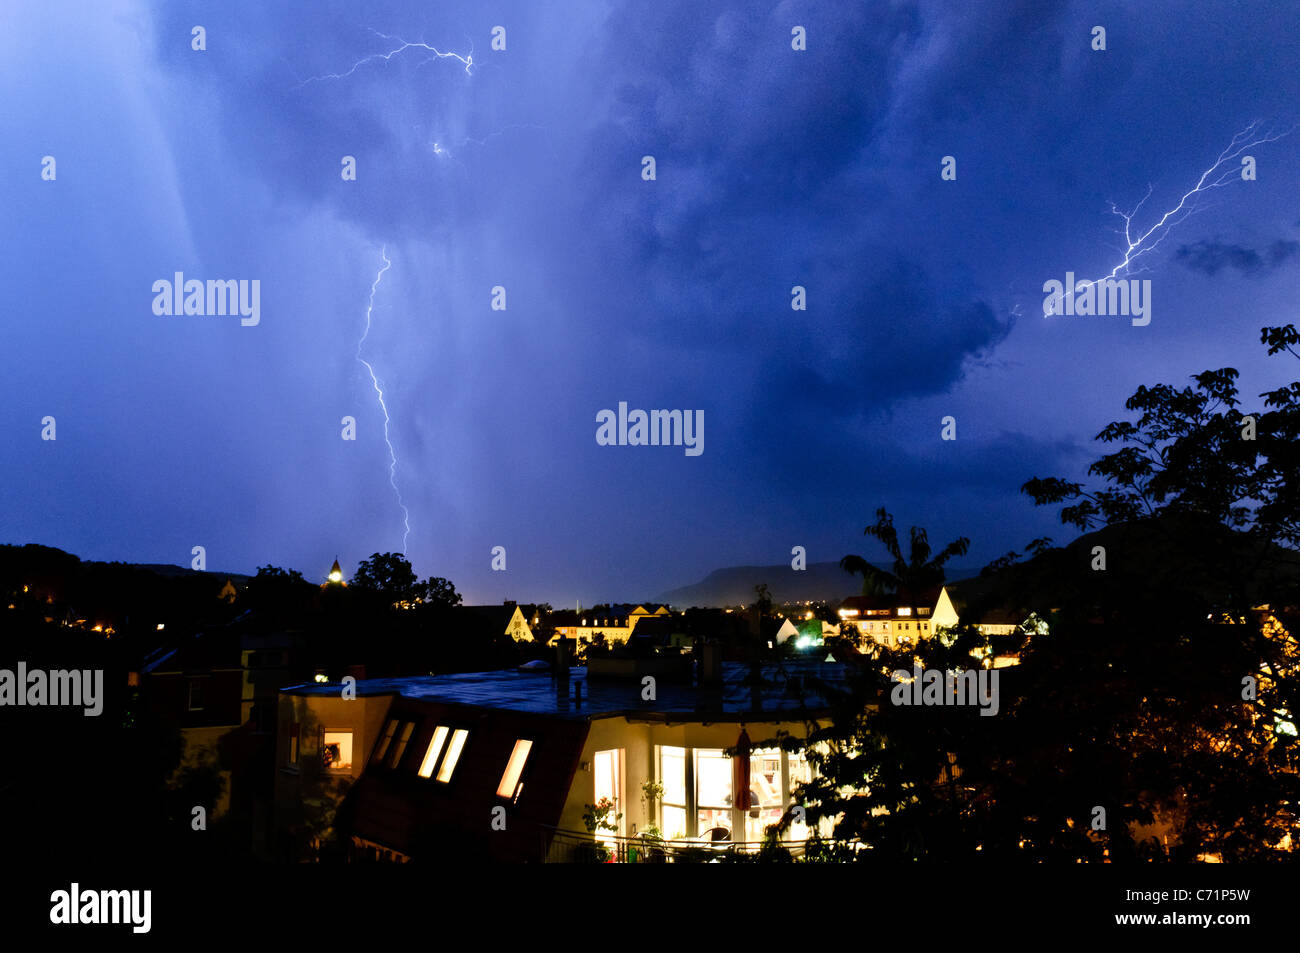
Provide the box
[282,659,844,722]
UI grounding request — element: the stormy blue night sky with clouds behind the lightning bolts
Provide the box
[0,0,1300,606]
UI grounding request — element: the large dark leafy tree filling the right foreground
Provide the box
[755,329,1300,862]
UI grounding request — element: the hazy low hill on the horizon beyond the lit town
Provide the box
[658,563,979,608]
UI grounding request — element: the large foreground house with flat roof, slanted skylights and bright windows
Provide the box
[276,651,842,862]
